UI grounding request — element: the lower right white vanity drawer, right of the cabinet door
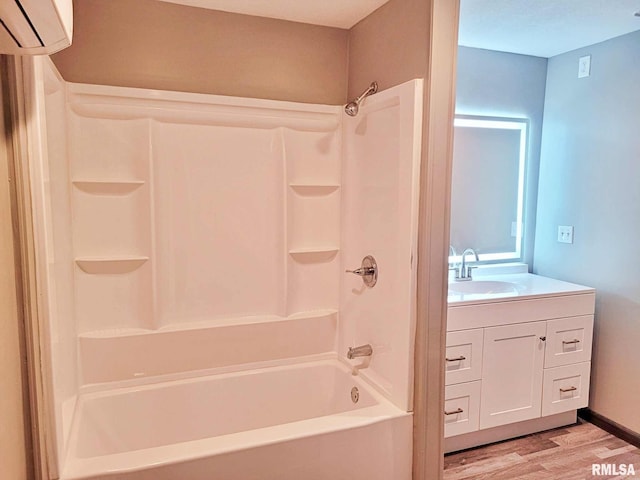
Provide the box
[542,362,591,416]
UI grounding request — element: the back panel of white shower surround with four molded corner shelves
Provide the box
[68,85,341,383]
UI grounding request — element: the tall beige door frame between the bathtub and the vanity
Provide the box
[413,0,460,480]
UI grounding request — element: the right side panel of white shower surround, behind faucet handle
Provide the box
[338,80,422,411]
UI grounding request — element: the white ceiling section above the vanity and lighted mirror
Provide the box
[459,0,640,58]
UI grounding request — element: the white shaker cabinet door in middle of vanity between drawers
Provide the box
[480,322,546,428]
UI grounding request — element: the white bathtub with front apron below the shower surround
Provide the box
[61,360,412,480]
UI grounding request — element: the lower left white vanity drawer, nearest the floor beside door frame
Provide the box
[444,380,481,437]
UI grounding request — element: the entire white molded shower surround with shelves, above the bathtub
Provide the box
[32,57,422,478]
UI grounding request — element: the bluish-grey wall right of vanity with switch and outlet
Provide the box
[534,32,640,432]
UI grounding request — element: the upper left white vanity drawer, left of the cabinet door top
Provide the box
[445,328,483,385]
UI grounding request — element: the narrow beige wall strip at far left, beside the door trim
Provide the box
[0,64,27,480]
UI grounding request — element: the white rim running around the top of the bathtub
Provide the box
[60,353,412,480]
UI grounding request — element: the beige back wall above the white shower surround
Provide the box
[52,0,348,104]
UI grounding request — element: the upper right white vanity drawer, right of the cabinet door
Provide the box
[544,315,593,368]
